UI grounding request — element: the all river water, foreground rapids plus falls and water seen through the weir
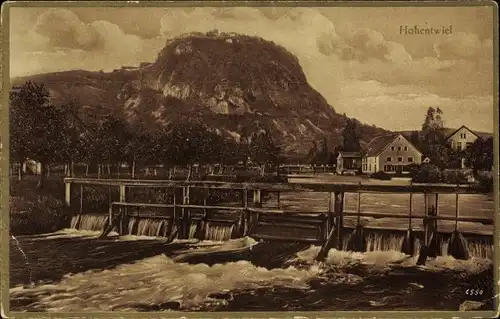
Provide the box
[10,178,494,312]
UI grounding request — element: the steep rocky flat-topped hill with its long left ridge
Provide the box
[13,32,384,155]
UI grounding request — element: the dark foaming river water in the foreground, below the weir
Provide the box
[10,230,492,312]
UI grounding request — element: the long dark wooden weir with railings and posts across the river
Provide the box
[64,178,493,262]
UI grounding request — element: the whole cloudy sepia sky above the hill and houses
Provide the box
[9,6,494,132]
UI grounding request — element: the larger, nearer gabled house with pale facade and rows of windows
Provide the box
[362,133,422,174]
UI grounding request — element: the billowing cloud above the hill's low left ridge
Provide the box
[10,9,164,76]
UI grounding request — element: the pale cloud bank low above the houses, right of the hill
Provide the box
[339,80,494,132]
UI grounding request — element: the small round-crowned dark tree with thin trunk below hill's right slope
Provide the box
[249,131,280,176]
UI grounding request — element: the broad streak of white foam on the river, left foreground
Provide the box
[10,256,320,312]
